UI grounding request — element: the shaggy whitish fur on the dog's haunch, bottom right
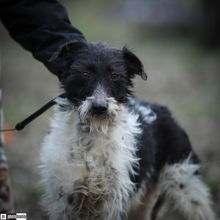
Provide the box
[159,157,216,220]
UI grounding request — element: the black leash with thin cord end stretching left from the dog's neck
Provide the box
[0,93,66,132]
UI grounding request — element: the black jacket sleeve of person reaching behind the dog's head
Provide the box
[0,0,84,76]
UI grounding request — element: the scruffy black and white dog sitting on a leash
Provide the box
[41,40,216,220]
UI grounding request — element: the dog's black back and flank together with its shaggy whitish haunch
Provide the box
[126,99,215,220]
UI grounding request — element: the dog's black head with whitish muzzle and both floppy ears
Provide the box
[52,40,147,132]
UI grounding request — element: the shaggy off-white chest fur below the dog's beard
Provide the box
[41,103,141,219]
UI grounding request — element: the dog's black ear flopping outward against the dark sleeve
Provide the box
[50,40,86,61]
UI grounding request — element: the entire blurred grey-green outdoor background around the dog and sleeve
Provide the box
[0,0,220,220]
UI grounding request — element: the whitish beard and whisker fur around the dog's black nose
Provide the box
[78,97,120,136]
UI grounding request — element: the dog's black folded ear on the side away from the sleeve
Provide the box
[122,47,147,80]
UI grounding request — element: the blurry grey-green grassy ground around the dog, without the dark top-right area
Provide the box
[0,0,220,220]
